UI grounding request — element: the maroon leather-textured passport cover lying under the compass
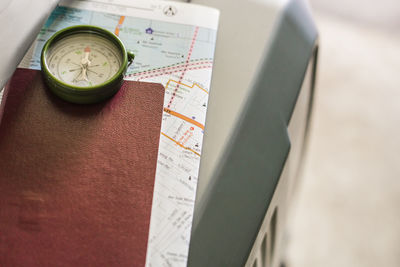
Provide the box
[0,69,164,266]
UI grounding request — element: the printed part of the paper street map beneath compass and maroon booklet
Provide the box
[25,1,216,266]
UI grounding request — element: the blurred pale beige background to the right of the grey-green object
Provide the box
[287,0,400,267]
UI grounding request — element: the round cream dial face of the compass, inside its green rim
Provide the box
[45,32,123,88]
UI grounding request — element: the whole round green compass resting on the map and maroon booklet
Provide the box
[41,25,134,104]
